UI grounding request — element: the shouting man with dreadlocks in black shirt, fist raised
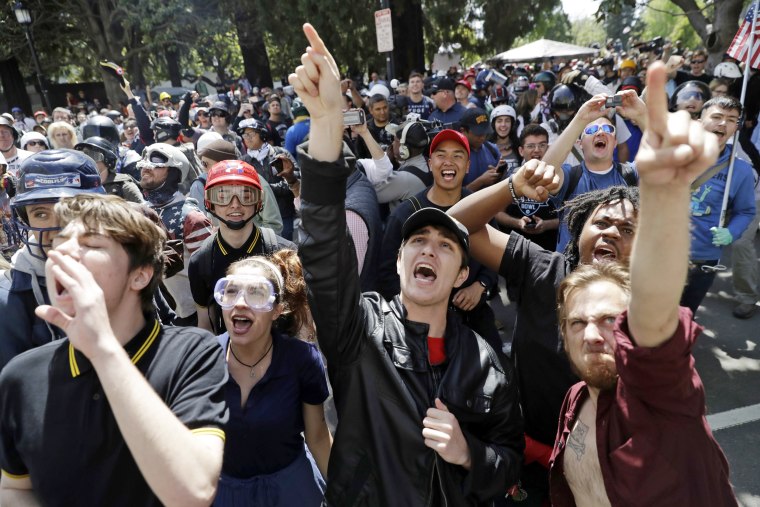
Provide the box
[449,173,639,505]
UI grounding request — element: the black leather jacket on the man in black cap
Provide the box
[298,148,524,507]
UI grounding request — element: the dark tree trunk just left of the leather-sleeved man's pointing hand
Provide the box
[235,1,272,87]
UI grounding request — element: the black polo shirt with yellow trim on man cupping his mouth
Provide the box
[0,316,227,507]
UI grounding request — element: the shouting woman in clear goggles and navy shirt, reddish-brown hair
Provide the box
[214,250,332,507]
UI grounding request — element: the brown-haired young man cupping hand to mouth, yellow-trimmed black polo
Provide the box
[0,195,227,506]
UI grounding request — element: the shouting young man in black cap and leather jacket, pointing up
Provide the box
[290,24,523,506]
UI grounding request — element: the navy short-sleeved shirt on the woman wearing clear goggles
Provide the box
[220,330,328,478]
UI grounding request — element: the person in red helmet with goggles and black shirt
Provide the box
[188,160,296,334]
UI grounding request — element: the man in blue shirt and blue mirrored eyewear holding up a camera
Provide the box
[543,90,646,252]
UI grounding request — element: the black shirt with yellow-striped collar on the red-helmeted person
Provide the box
[187,227,296,334]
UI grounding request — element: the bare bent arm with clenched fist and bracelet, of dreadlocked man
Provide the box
[448,160,561,272]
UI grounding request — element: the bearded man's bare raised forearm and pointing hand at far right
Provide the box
[628,62,718,347]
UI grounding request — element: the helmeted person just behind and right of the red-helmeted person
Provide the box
[237,118,299,240]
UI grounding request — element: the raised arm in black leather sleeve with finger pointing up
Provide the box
[289,23,364,366]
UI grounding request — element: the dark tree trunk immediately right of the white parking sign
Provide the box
[388,0,425,81]
